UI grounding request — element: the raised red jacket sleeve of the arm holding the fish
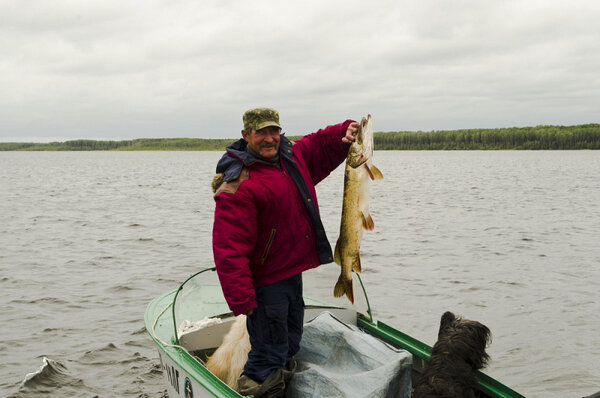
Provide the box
[294,120,353,185]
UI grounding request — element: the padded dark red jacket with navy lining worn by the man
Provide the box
[213,120,352,315]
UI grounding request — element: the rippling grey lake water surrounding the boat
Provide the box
[0,151,600,398]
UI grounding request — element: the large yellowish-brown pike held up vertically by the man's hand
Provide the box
[333,115,383,304]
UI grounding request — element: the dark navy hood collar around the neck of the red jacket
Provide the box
[217,134,293,182]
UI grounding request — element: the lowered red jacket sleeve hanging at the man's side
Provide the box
[213,189,257,315]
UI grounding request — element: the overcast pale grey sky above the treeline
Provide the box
[0,0,600,142]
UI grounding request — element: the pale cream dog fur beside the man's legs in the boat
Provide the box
[206,315,250,391]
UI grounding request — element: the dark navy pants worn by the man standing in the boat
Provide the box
[243,274,304,383]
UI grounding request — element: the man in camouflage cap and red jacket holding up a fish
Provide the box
[213,108,359,397]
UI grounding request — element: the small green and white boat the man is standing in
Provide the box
[144,267,524,398]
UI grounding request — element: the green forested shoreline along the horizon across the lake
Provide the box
[0,124,600,151]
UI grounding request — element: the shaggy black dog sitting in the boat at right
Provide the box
[412,312,492,398]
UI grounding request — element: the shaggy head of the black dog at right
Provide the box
[432,311,492,370]
